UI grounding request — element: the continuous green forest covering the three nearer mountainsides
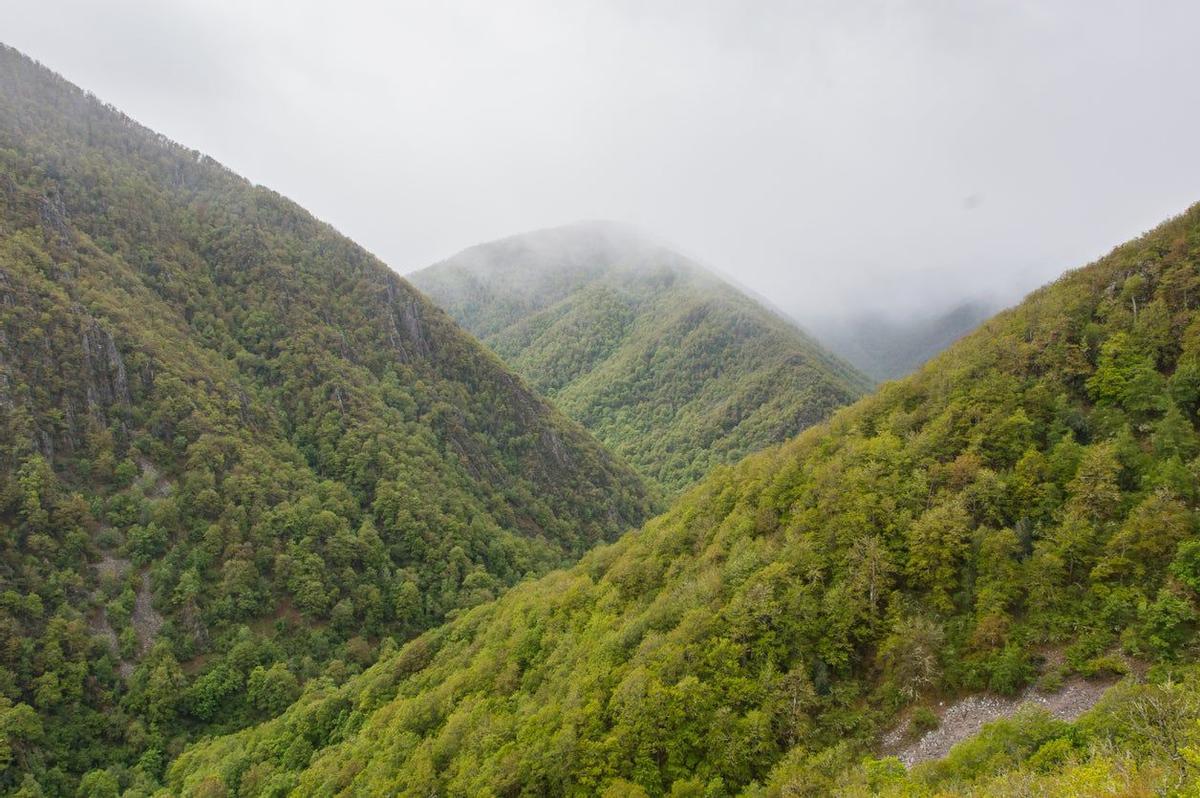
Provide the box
[0,34,1200,798]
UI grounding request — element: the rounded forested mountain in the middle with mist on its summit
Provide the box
[410,222,870,493]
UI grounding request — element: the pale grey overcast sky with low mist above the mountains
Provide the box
[0,0,1200,320]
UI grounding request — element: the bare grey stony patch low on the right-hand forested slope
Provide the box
[881,678,1115,767]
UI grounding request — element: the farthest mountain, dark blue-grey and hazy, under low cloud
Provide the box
[805,300,996,382]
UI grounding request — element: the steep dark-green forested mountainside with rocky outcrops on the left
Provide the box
[0,47,649,794]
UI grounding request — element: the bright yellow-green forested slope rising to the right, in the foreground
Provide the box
[175,205,1200,797]
